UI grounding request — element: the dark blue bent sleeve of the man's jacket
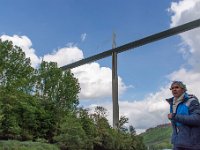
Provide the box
[172,100,200,126]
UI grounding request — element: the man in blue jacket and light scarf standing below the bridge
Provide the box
[166,81,200,150]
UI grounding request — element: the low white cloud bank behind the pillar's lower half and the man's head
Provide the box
[89,68,200,133]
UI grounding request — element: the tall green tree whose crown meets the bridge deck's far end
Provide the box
[35,61,80,141]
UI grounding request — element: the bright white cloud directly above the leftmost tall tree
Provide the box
[0,35,41,67]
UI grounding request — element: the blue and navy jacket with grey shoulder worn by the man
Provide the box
[166,93,200,150]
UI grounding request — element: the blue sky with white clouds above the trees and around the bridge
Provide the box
[0,0,200,133]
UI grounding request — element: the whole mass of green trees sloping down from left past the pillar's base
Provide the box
[0,40,146,150]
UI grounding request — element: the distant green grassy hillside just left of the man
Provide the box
[140,124,172,150]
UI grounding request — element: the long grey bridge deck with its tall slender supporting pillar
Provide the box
[61,19,200,128]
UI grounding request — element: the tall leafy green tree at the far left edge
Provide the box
[0,40,34,138]
